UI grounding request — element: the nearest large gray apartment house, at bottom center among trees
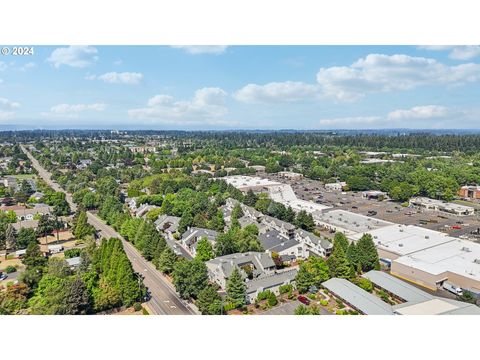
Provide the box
[205,251,275,289]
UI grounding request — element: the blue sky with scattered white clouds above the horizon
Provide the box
[0,46,480,130]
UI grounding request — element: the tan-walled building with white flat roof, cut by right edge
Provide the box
[391,238,480,291]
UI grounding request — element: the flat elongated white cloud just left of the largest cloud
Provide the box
[234,81,319,103]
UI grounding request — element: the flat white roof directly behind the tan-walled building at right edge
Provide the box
[351,224,456,256]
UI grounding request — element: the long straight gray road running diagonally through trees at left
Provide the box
[21,145,196,315]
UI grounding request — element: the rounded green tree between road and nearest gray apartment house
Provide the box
[172,259,208,299]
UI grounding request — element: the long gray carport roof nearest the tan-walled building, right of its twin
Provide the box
[362,270,433,302]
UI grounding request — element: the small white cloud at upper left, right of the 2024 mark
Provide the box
[47,46,98,68]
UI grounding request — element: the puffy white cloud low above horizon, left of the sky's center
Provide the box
[128,87,228,124]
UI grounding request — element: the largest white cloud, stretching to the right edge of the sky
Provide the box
[317,54,480,101]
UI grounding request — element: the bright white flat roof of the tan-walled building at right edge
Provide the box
[395,238,480,281]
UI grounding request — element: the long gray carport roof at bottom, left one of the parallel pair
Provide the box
[322,278,393,315]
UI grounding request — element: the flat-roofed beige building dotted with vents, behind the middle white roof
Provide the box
[313,210,393,238]
